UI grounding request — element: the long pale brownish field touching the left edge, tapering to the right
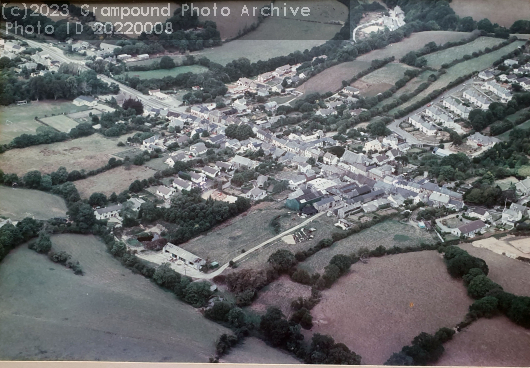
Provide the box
[0,133,134,175]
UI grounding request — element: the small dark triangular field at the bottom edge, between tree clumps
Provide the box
[219,337,301,364]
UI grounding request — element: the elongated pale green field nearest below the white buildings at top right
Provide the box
[357,31,470,61]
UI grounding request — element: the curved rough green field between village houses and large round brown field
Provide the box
[294,220,433,273]
